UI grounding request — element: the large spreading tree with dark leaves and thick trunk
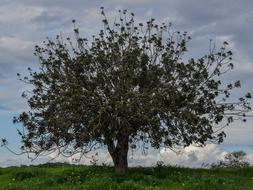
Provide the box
[14,8,251,172]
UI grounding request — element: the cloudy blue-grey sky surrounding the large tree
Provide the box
[0,0,253,167]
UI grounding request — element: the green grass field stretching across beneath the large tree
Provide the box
[0,164,253,190]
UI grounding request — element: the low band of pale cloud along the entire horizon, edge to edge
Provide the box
[0,144,253,168]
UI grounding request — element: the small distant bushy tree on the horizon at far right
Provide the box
[211,151,250,168]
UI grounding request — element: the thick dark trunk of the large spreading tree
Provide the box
[107,136,129,174]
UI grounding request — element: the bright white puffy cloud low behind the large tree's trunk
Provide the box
[50,144,226,167]
